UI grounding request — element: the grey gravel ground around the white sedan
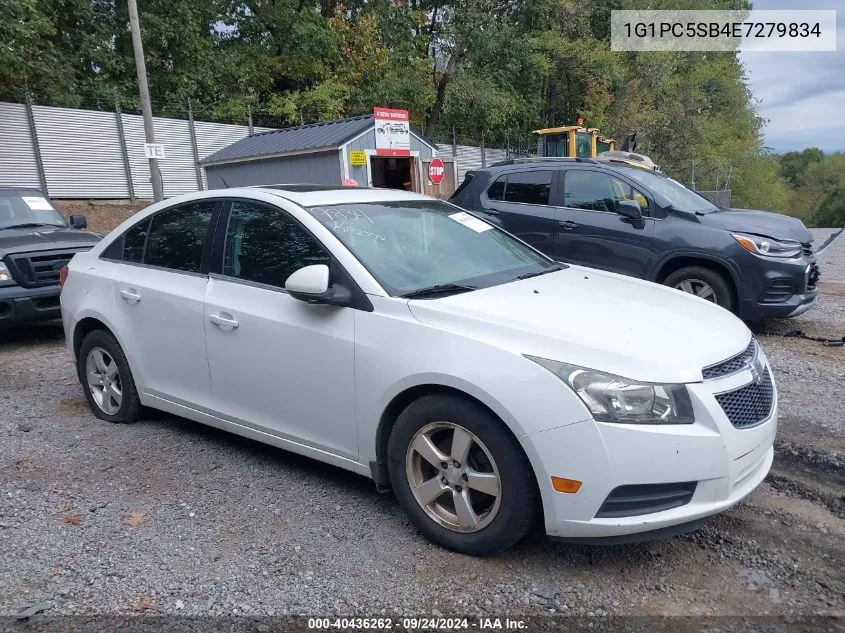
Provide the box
[0,228,845,622]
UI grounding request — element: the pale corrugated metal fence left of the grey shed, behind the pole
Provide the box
[0,102,269,199]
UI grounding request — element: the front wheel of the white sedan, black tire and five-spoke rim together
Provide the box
[387,395,538,555]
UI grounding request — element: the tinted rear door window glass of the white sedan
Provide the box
[143,200,217,273]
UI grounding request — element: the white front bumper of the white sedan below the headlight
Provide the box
[520,350,777,539]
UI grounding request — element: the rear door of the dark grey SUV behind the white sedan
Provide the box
[481,169,558,256]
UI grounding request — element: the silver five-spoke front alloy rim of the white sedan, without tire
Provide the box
[405,422,502,534]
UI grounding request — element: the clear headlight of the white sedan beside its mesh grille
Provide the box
[526,356,695,424]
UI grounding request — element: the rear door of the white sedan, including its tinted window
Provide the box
[109,200,220,405]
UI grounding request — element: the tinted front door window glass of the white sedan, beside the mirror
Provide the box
[223,201,331,288]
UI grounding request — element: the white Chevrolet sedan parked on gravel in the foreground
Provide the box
[61,186,777,554]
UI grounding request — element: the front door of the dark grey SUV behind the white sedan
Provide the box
[554,168,656,279]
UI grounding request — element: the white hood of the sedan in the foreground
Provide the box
[408,266,751,383]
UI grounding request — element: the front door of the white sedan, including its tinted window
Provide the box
[205,201,358,459]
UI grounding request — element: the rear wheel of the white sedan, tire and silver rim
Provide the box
[76,330,141,423]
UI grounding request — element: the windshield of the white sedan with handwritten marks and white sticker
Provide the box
[308,200,561,296]
